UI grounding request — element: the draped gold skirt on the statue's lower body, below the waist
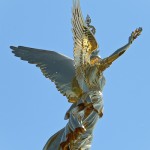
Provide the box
[43,91,103,150]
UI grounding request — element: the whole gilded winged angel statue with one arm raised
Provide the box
[10,0,142,150]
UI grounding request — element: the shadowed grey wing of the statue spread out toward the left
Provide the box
[10,46,77,100]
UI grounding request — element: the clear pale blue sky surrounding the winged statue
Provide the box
[0,0,150,150]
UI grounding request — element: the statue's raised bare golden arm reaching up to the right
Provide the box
[102,28,142,70]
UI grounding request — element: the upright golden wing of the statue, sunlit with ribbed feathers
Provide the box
[72,0,98,89]
